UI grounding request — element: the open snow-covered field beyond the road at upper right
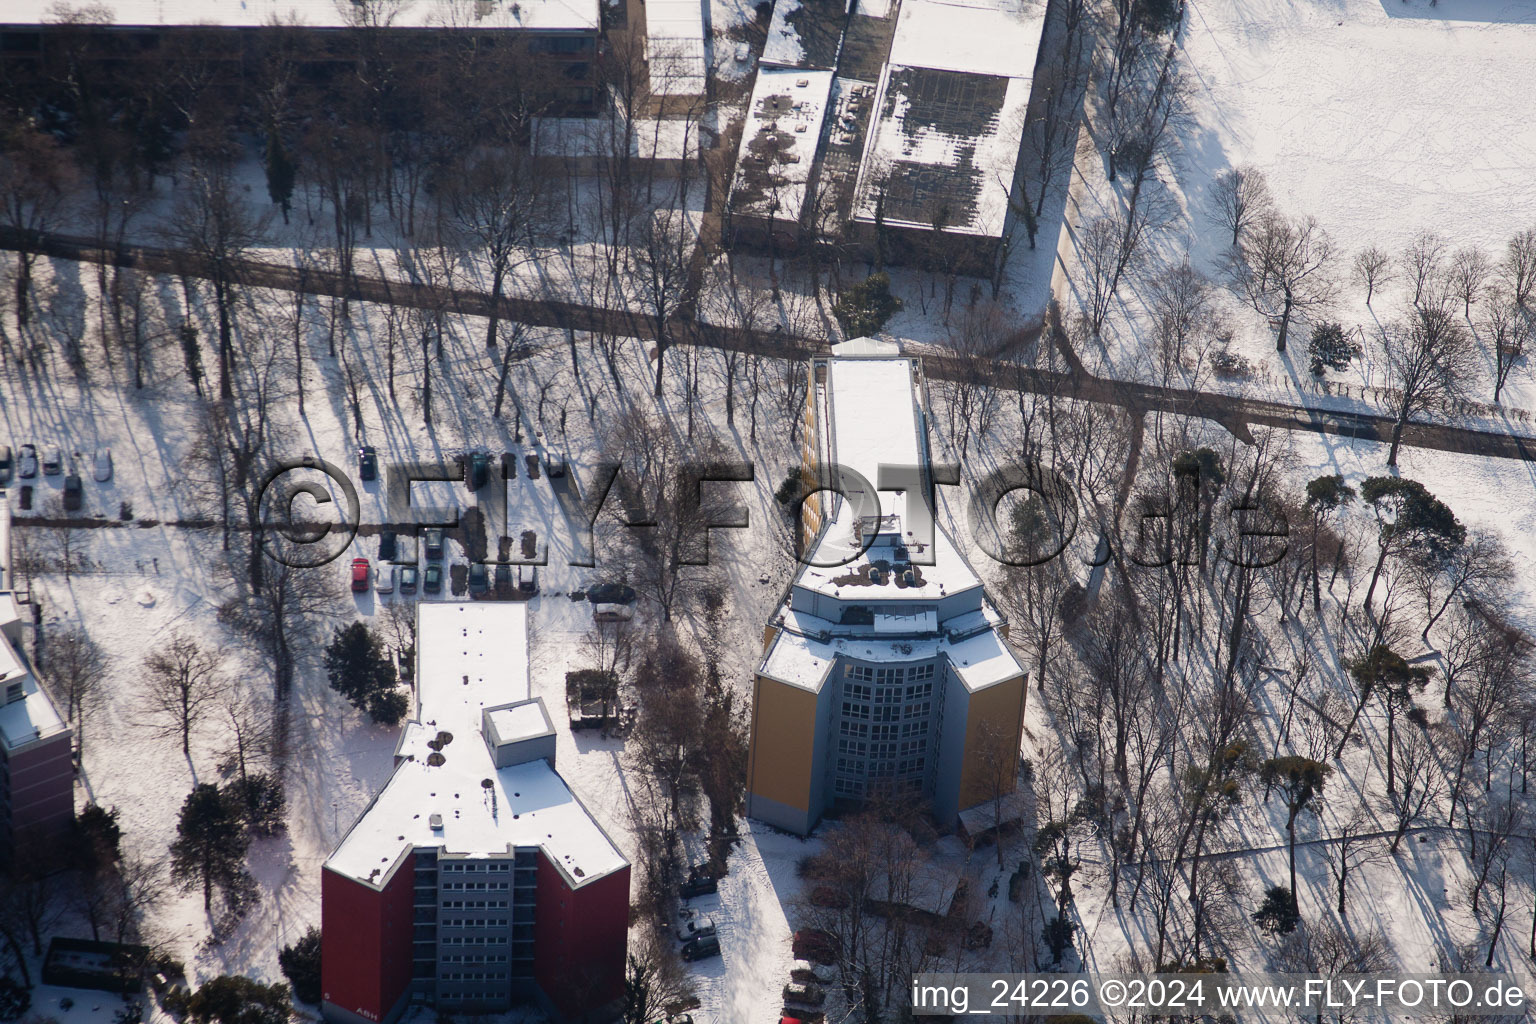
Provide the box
[1061,0,1536,414]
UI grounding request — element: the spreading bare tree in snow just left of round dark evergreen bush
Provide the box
[1229,213,1333,352]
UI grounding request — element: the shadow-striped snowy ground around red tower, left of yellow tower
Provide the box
[0,244,829,1024]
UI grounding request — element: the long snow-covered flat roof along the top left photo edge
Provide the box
[0,0,598,31]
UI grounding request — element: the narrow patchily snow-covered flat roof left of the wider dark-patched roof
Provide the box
[731,66,833,224]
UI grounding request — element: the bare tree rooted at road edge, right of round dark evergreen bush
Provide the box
[1378,304,1473,465]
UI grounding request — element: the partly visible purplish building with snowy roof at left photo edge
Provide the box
[0,491,75,861]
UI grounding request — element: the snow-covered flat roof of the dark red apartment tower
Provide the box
[326,602,627,887]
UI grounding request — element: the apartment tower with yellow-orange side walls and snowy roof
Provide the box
[746,338,1028,834]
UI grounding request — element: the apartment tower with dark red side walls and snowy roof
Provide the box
[321,602,630,1024]
